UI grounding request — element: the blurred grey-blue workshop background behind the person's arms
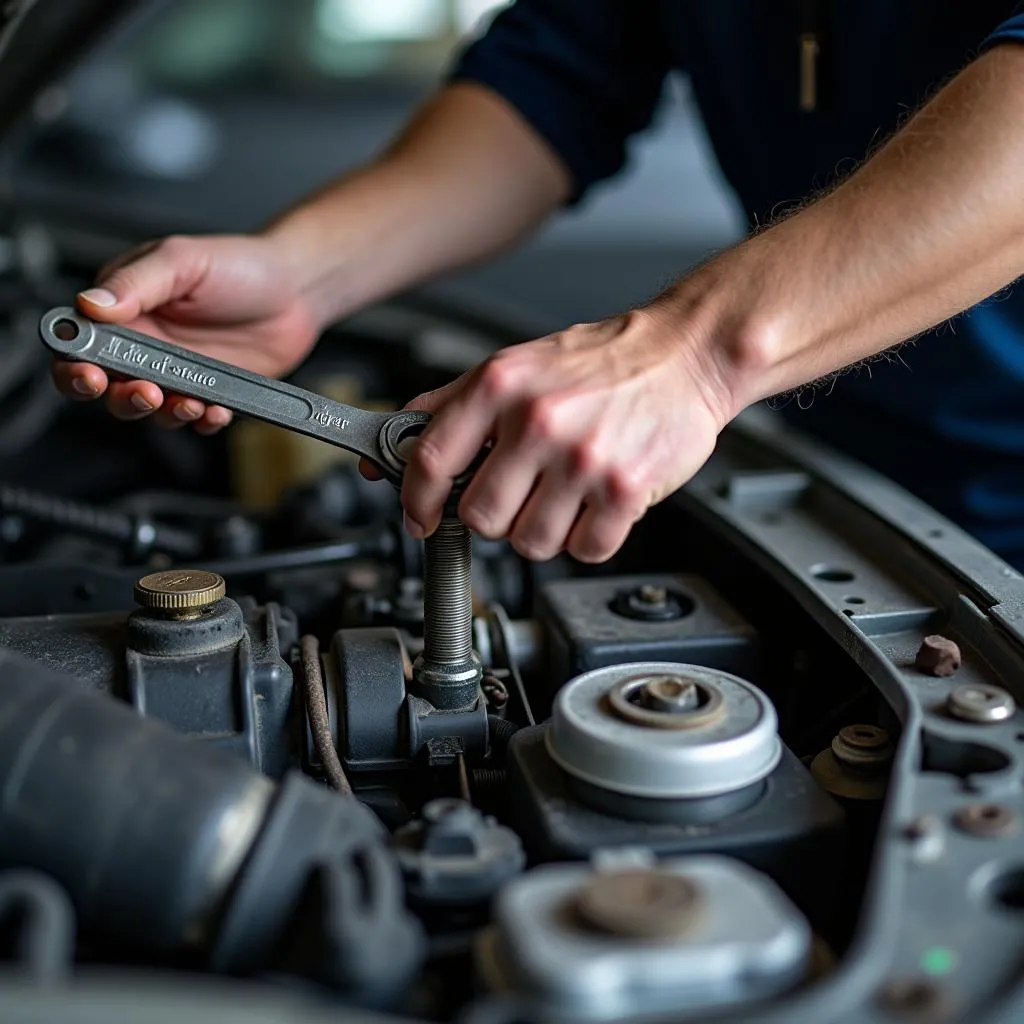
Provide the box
[14,0,742,330]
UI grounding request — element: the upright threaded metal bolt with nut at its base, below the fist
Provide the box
[413,512,483,711]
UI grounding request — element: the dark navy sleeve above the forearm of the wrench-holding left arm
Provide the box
[450,0,672,202]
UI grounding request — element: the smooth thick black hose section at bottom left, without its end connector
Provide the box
[0,649,274,951]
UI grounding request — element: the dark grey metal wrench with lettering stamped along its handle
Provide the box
[39,306,432,485]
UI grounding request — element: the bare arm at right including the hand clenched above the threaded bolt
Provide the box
[402,44,1024,561]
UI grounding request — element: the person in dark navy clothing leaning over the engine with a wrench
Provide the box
[54,0,1024,565]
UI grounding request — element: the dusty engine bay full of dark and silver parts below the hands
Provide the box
[0,305,1024,1024]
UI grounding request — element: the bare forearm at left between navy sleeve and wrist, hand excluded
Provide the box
[266,84,570,324]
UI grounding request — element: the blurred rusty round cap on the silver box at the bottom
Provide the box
[574,867,701,939]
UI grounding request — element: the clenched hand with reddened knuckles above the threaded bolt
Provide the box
[402,310,730,562]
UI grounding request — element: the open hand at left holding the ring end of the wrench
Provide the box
[53,236,318,434]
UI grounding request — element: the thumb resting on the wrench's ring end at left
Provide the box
[78,238,209,324]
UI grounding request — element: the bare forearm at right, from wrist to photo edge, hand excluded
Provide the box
[650,39,1024,418]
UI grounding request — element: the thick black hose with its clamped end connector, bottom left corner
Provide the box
[0,648,422,998]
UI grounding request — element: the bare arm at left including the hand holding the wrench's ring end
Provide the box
[53,83,570,433]
